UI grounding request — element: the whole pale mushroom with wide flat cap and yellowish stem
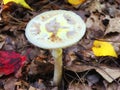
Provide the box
[25,10,86,85]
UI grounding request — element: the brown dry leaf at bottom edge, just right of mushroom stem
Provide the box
[67,83,92,90]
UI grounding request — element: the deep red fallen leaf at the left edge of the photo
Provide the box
[0,51,26,75]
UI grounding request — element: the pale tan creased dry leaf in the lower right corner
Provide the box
[95,66,120,83]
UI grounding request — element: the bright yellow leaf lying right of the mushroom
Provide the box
[92,40,117,57]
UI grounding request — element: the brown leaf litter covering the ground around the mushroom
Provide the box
[0,0,120,90]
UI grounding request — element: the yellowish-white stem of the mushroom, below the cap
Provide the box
[52,48,62,86]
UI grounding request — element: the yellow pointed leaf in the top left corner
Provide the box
[3,0,33,10]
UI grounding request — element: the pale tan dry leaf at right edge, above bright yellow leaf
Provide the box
[105,17,120,34]
